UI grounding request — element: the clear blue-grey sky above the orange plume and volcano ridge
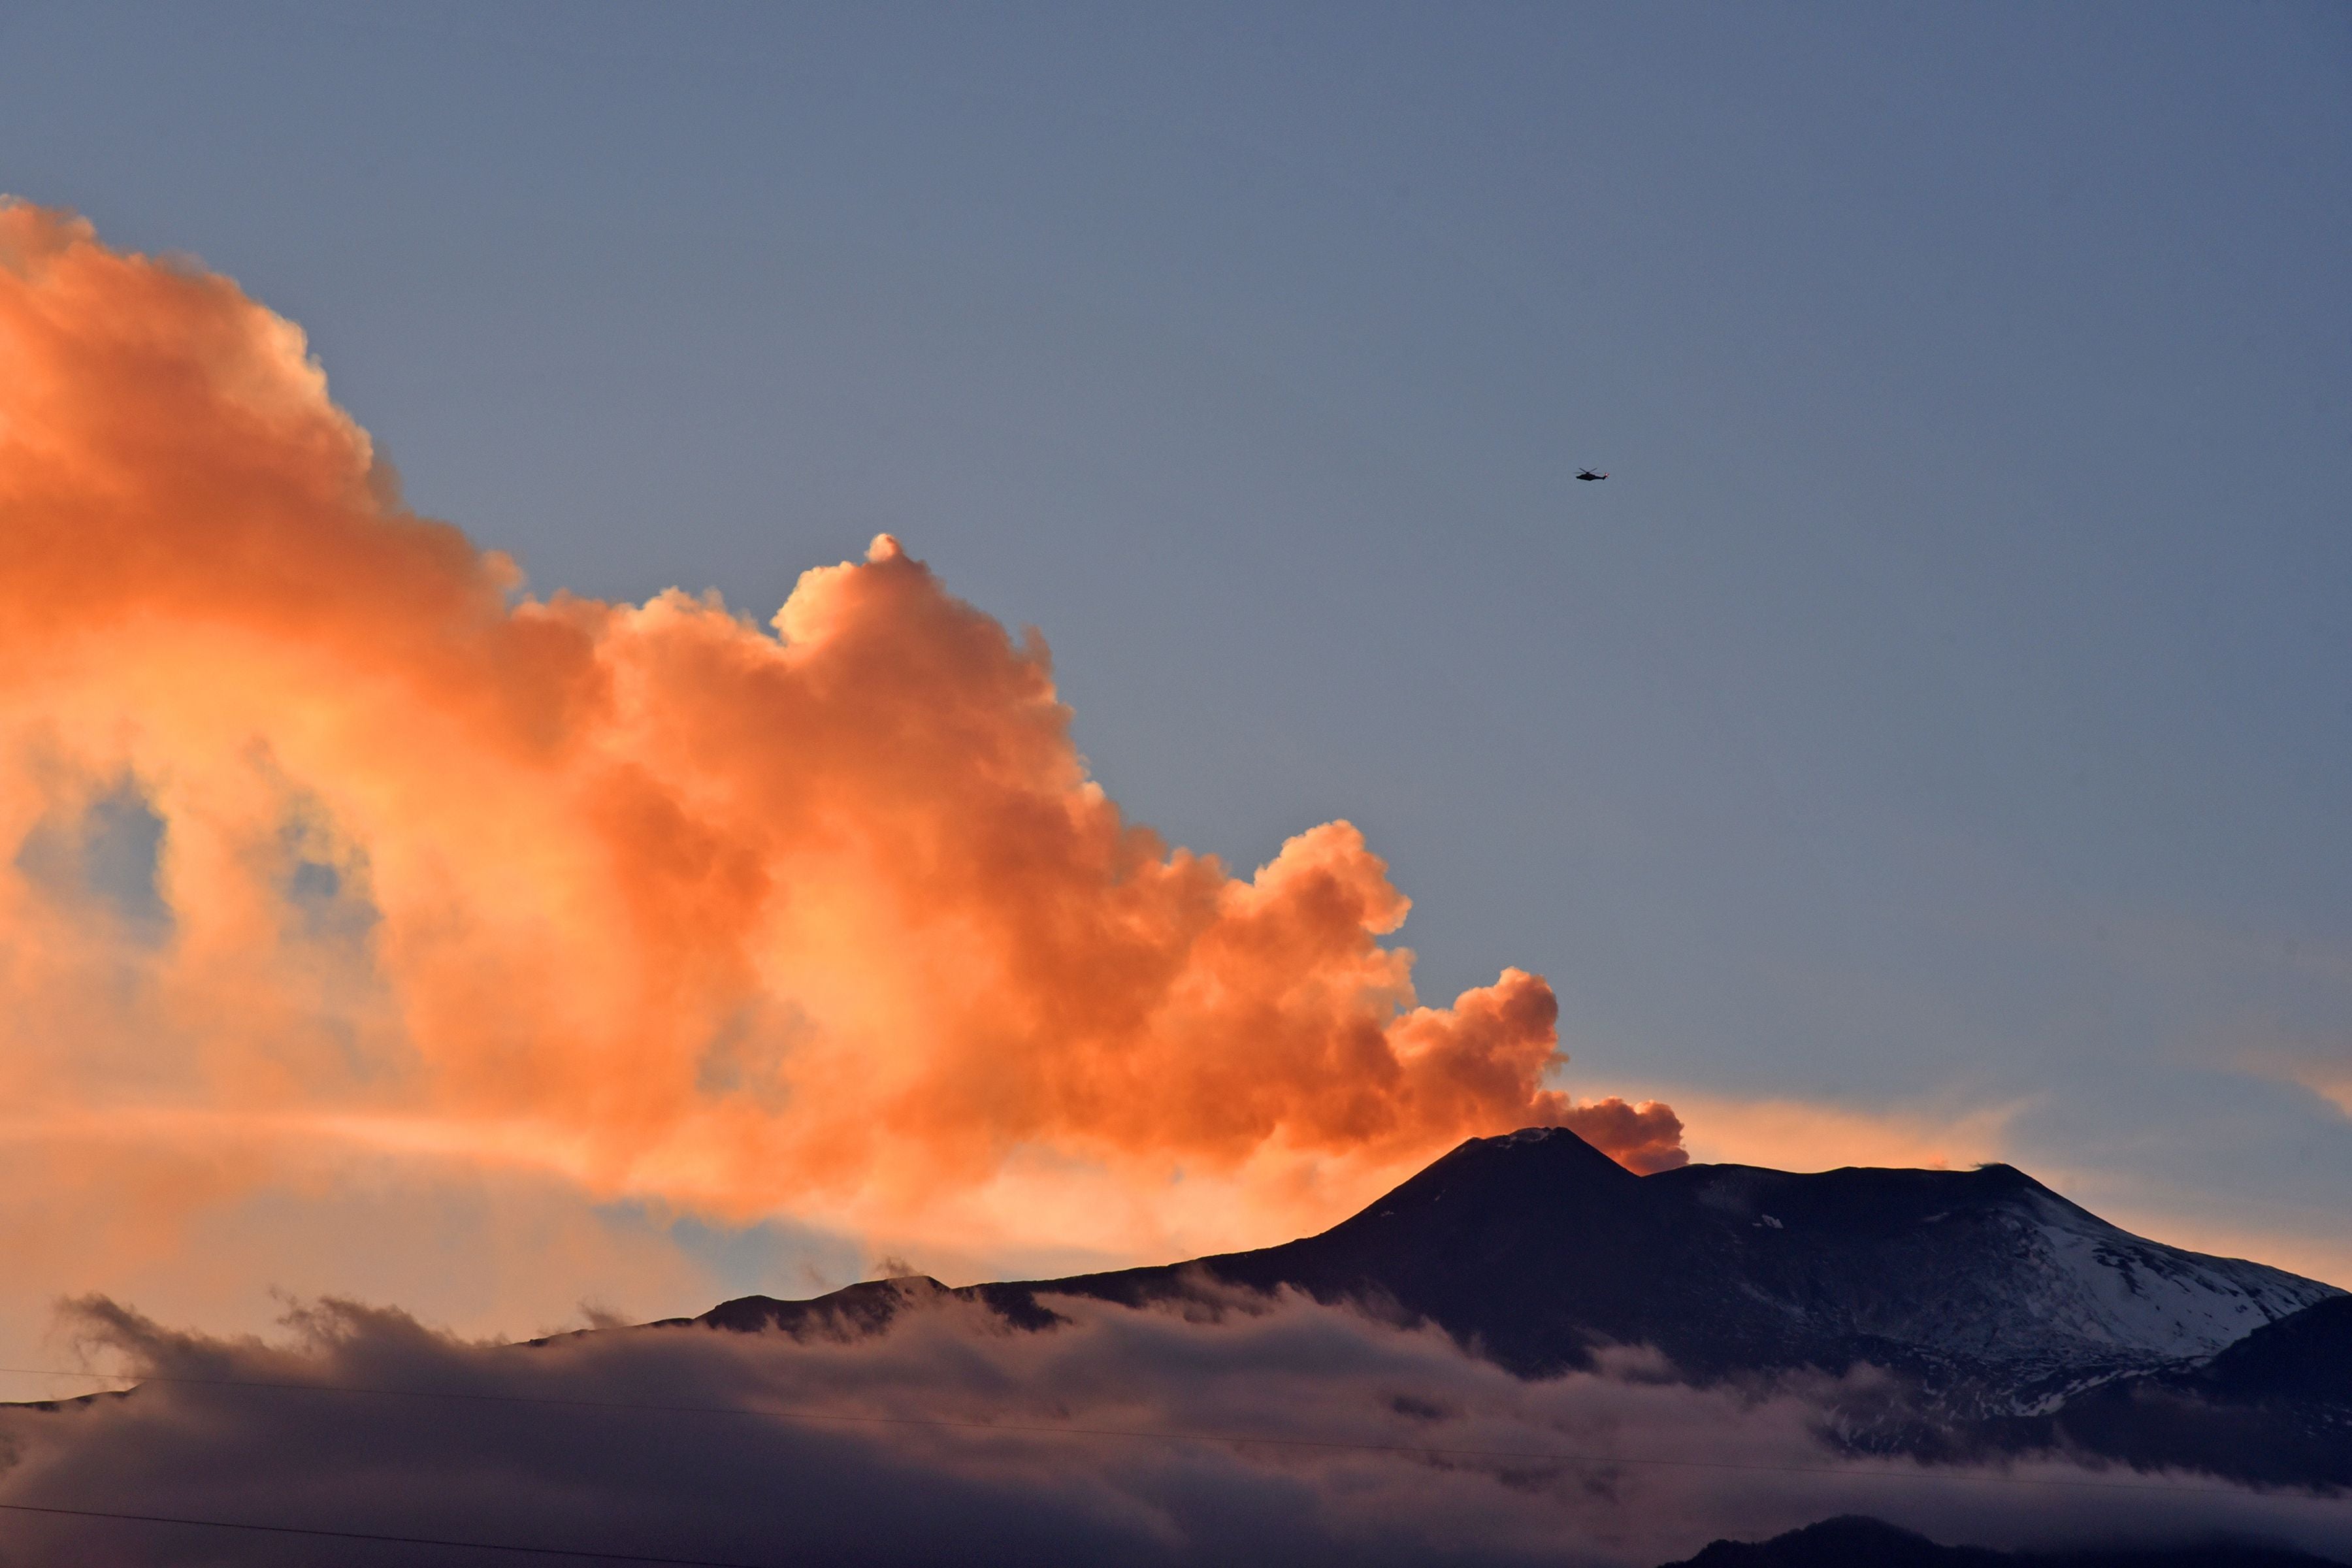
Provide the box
[0,0,2352,1284]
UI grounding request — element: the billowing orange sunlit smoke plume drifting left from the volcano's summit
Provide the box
[0,204,1682,1288]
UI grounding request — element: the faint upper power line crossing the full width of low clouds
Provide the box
[0,1366,2347,1504]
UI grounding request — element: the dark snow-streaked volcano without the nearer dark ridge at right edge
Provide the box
[703,1128,2338,1415]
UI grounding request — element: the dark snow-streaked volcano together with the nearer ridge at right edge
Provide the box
[672,1128,2352,1486]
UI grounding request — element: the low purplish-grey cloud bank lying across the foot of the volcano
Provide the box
[0,1298,2352,1568]
